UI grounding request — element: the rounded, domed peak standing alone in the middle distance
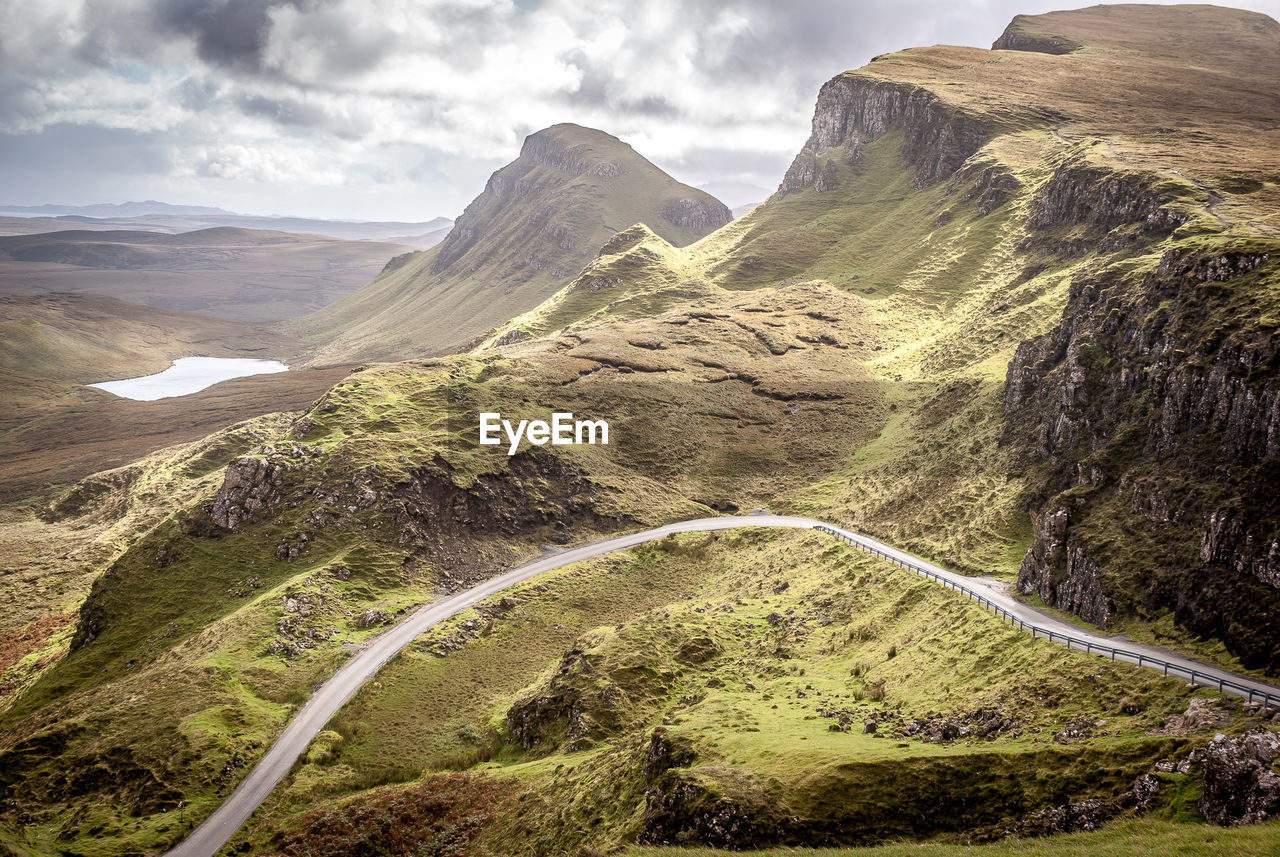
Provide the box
[289,124,731,362]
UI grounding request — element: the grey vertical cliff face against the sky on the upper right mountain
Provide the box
[778,72,991,193]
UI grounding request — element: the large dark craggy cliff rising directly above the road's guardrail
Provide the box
[1004,248,1280,672]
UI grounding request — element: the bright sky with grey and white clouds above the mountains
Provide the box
[0,0,1280,220]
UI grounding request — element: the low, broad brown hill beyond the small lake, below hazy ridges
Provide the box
[0,226,413,322]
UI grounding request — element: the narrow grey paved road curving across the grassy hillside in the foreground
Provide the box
[165,514,1280,857]
